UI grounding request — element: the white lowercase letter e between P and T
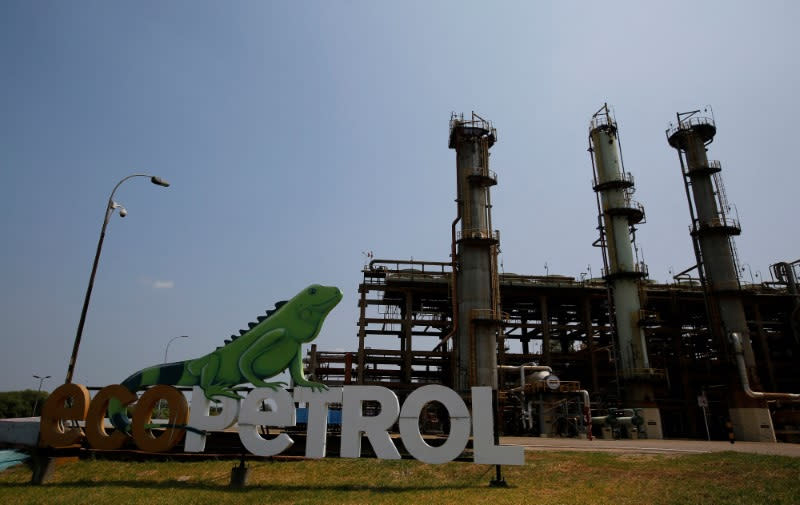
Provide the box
[239,388,295,456]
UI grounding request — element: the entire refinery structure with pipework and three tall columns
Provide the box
[305,106,800,441]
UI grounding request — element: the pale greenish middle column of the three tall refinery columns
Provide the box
[589,104,663,439]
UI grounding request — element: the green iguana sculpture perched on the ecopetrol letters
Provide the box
[108,284,342,432]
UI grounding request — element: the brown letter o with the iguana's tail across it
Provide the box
[131,384,189,452]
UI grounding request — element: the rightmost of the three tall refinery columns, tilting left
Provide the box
[667,110,775,442]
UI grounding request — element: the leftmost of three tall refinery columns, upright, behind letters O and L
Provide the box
[449,113,500,393]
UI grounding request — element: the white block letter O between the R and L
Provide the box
[399,385,470,463]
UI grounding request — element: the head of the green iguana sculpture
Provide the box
[280,284,342,342]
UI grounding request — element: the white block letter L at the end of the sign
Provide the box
[472,387,525,465]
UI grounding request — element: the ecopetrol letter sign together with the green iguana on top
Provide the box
[40,284,524,465]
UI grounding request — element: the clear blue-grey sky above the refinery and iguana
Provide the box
[0,0,800,390]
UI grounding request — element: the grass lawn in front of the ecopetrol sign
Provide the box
[0,452,800,505]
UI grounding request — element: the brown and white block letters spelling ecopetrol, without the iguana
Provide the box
[40,384,525,465]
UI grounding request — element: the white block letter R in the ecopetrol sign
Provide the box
[341,386,400,459]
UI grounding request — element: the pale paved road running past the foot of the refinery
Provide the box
[500,437,800,458]
